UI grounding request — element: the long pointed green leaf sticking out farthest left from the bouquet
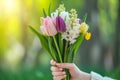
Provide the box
[29,26,50,53]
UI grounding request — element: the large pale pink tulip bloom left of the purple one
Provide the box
[40,17,57,36]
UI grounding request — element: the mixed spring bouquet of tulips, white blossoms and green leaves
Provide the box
[29,4,91,80]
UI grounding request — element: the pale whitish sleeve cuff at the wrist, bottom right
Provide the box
[90,71,115,80]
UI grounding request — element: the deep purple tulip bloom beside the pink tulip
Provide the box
[56,16,66,32]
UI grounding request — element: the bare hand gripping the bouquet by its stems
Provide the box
[51,60,91,80]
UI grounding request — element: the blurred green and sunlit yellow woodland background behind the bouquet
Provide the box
[0,0,120,80]
